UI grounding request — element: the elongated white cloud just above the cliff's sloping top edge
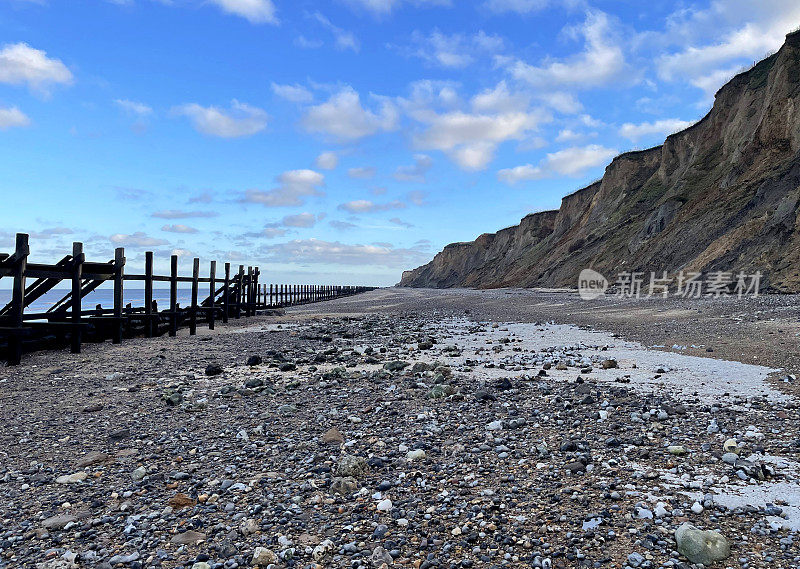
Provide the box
[497,144,617,185]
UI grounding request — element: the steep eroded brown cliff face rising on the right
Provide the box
[400,28,800,291]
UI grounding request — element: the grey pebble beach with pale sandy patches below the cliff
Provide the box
[0,289,800,569]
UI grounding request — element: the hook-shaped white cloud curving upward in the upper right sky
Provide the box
[509,10,625,89]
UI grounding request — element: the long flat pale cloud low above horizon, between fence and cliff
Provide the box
[260,239,424,267]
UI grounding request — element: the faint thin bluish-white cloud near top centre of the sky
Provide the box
[408,29,503,68]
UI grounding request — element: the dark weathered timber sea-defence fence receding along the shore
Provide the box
[0,233,374,365]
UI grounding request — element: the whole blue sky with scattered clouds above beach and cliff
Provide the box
[0,0,800,285]
